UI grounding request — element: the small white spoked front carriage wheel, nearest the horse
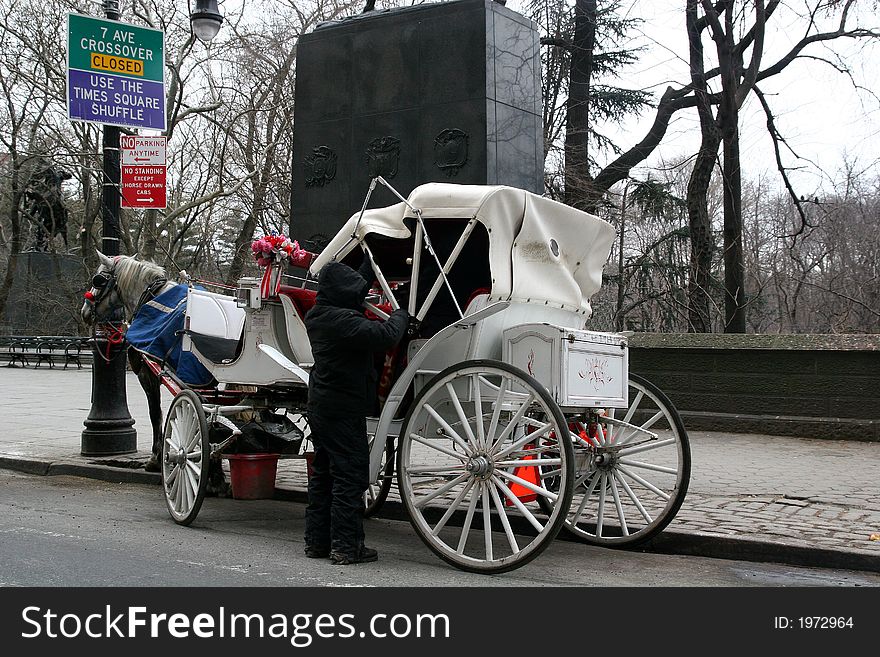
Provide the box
[162,390,211,525]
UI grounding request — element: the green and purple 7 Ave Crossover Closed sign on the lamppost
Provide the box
[67,14,166,130]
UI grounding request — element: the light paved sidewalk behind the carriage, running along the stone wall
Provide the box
[0,367,880,572]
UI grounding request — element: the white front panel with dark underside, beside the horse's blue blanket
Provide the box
[186,288,245,363]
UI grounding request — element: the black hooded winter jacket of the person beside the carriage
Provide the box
[305,262,409,416]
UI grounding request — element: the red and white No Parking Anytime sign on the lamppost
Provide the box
[119,135,167,208]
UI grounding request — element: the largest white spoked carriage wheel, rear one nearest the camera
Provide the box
[397,360,574,573]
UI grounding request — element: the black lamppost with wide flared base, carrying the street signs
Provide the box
[80,0,223,456]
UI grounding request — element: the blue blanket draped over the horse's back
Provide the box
[125,285,214,386]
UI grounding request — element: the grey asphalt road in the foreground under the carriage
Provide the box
[0,471,880,587]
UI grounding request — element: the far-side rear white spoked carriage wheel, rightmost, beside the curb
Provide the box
[544,374,691,547]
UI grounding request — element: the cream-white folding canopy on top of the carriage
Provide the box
[311,183,615,314]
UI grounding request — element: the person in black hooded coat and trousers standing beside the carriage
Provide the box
[305,262,409,565]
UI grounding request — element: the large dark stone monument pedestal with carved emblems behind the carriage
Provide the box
[290,0,544,250]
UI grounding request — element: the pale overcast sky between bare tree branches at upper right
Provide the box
[524,0,880,194]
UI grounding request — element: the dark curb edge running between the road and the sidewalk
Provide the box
[0,456,880,573]
